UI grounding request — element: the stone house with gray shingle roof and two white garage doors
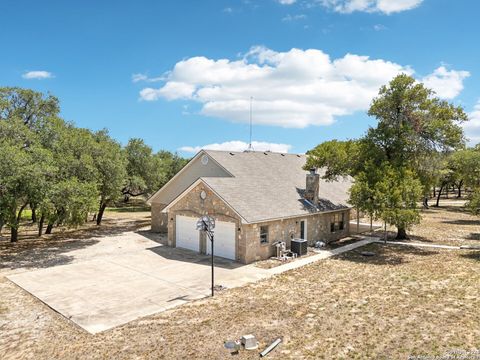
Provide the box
[149,150,351,264]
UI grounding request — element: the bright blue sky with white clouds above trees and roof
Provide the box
[0,0,480,156]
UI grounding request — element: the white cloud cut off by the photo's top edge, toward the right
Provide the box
[317,0,423,14]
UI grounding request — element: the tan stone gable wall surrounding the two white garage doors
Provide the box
[168,184,246,262]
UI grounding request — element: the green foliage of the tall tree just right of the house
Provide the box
[307,75,468,237]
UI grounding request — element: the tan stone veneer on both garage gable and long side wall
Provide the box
[167,184,350,264]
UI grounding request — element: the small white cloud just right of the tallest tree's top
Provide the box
[422,66,470,99]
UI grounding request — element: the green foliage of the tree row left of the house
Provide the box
[0,87,186,241]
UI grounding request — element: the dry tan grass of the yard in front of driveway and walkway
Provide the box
[0,201,480,359]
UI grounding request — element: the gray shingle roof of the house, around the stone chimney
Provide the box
[202,150,352,223]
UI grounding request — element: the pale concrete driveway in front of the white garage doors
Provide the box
[7,232,269,333]
